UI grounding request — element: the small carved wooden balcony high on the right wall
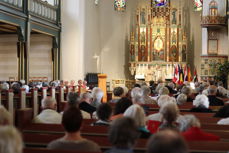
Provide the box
[201,16,227,28]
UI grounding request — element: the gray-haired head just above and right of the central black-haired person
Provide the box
[131,87,144,104]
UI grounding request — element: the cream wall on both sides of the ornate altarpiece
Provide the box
[62,0,202,80]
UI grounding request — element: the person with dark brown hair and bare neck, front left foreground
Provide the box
[47,107,101,152]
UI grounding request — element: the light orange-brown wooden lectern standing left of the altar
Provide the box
[98,74,107,102]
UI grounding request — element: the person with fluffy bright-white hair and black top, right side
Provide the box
[190,94,212,113]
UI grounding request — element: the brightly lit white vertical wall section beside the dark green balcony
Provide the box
[61,0,86,80]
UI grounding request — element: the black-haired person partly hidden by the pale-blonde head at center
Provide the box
[111,98,133,120]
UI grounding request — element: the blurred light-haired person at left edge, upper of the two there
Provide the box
[0,105,13,126]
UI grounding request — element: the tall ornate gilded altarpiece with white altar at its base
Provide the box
[130,0,187,81]
